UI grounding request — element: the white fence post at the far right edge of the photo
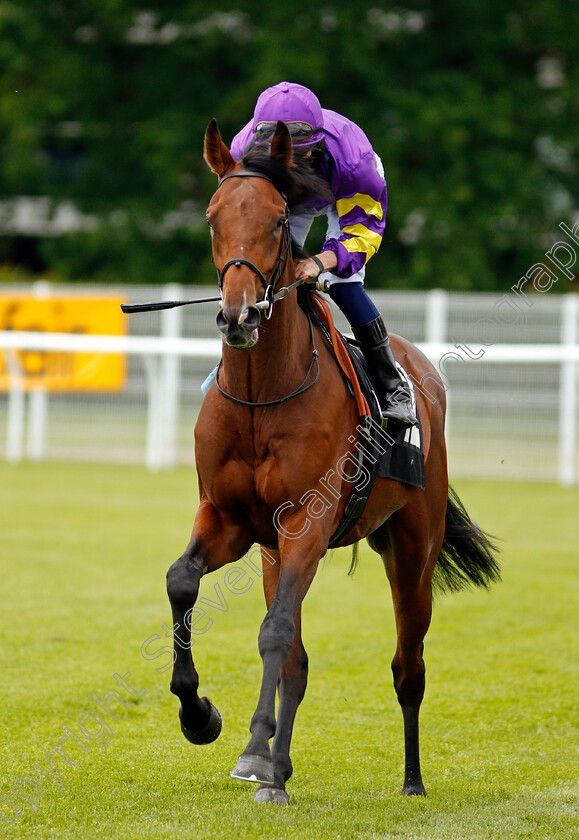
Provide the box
[557,293,579,487]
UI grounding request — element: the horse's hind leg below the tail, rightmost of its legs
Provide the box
[376,492,444,796]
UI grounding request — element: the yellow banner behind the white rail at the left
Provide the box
[0,295,126,391]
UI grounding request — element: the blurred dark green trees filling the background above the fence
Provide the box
[0,0,579,291]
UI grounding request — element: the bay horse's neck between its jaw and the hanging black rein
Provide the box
[222,293,312,402]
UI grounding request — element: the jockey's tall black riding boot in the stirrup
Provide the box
[353,316,417,428]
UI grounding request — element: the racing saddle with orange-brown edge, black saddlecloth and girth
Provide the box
[313,295,425,548]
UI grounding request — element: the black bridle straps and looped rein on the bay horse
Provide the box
[215,169,320,408]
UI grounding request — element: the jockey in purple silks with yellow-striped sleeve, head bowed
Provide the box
[231,82,417,427]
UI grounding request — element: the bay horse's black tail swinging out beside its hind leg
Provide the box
[433,487,501,592]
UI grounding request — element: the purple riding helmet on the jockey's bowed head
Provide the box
[252,82,324,147]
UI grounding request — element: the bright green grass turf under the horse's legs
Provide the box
[0,463,579,840]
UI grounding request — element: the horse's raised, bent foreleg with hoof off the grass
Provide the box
[167,503,250,744]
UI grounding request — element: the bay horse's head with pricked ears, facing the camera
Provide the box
[204,120,292,349]
